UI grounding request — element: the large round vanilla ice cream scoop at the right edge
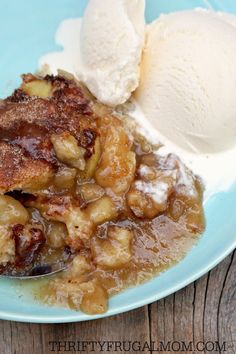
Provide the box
[136,10,236,153]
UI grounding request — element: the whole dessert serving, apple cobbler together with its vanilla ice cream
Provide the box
[5,0,236,314]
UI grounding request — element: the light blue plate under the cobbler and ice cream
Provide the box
[0,0,236,323]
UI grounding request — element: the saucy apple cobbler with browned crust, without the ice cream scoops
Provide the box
[0,74,204,314]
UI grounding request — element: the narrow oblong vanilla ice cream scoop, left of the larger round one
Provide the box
[80,0,145,106]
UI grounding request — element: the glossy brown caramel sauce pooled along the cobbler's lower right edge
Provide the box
[35,148,205,314]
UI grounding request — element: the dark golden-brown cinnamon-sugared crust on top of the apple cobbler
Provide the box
[0,75,97,193]
